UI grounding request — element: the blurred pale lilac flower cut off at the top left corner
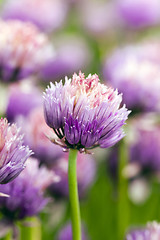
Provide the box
[2,0,68,32]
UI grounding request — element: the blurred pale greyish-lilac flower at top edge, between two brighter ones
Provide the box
[79,0,119,37]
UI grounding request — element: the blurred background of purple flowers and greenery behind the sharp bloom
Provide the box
[0,0,160,240]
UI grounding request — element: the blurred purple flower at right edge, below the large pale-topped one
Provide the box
[109,113,160,178]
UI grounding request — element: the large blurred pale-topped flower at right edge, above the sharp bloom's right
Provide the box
[104,42,160,112]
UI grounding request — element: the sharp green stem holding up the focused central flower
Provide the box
[68,149,81,240]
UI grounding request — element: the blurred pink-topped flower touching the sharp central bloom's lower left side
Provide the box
[17,107,63,168]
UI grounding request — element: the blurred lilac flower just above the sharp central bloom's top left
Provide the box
[42,35,91,81]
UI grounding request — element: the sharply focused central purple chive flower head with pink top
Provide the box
[44,72,129,152]
